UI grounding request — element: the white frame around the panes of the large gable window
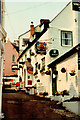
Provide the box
[61,30,73,47]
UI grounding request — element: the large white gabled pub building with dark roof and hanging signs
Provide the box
[18,2,80,96]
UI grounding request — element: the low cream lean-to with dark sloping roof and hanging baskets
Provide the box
[48,43,80,97]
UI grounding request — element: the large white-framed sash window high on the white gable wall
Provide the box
[61,31,73,46]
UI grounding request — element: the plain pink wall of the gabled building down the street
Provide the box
[4,40,18,76]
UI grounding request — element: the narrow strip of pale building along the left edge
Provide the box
[0,0,7,118]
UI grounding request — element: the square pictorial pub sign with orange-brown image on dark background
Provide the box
[35,42,46,55]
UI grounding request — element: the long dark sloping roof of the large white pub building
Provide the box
[17,29,47,61]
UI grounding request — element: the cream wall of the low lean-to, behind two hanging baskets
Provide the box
[57,54,78,96]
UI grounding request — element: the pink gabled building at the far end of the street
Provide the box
[3,39,19,84]
